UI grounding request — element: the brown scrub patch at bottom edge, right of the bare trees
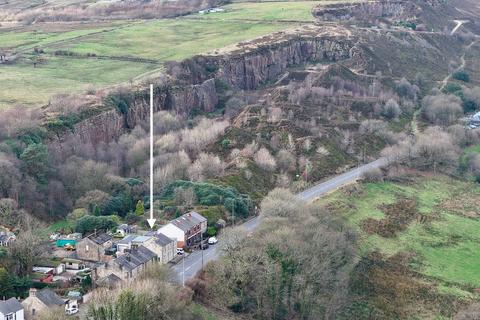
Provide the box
[340,252,459,320]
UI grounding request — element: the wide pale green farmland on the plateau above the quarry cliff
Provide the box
[0,1,331,108]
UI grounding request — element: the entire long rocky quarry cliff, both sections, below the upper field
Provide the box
[50,28,354,151]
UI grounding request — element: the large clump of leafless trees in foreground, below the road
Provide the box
[192,189,355,319]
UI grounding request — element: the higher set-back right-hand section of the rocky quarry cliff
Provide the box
[171,30,355,90]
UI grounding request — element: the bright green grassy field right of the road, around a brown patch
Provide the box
[320,177,480,296]
